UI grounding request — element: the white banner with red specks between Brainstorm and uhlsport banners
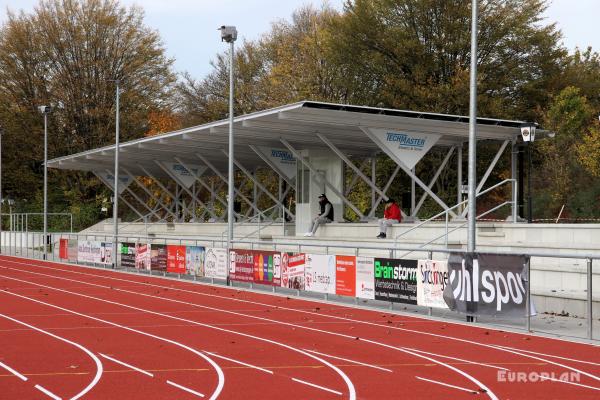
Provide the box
[417,260,449,308]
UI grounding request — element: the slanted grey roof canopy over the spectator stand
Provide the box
[48,101,539,177]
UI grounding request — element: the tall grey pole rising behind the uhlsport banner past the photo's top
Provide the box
[467,0,478,253]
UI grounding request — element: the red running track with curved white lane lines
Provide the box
[0,256,600,400]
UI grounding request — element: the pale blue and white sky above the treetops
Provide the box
[0,0,600,78]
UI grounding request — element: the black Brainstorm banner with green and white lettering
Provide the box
[375,258,418,304]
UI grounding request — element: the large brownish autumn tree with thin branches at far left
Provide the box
[0,0,175,228]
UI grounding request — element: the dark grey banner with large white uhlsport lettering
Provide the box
[444,253,528,318]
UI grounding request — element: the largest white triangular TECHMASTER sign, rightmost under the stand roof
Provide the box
[366,128,441,169]
